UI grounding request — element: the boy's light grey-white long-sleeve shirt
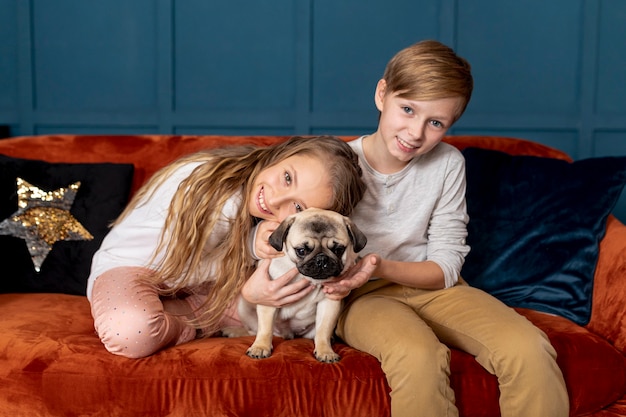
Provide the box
[350,137,469,288]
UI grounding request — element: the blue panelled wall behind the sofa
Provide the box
[0,0,626,220]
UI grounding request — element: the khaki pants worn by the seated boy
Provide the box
[337,281,569,417]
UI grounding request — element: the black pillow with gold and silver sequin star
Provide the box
[0,155,133,295]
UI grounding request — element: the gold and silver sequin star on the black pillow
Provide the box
[0,178,93,272]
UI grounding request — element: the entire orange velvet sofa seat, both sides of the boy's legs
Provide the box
[0,294,626,417]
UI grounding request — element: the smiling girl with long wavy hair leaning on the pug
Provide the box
[87,136,365,358]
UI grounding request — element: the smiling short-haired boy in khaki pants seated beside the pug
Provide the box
[326,41,569,417]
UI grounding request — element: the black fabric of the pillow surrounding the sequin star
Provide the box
[0,155,133,295]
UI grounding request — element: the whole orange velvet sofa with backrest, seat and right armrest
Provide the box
[0,135,626,417]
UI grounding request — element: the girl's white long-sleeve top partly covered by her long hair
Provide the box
[87,162,241,300]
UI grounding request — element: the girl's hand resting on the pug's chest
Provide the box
[241,259,314,307]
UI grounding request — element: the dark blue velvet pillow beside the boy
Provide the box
[461,148,626,325]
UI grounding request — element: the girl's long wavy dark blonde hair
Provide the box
[117,136,366,334]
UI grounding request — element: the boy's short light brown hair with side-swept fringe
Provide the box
[383,40,474,119]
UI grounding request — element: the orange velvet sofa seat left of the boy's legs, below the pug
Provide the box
[0,294,389,417]
